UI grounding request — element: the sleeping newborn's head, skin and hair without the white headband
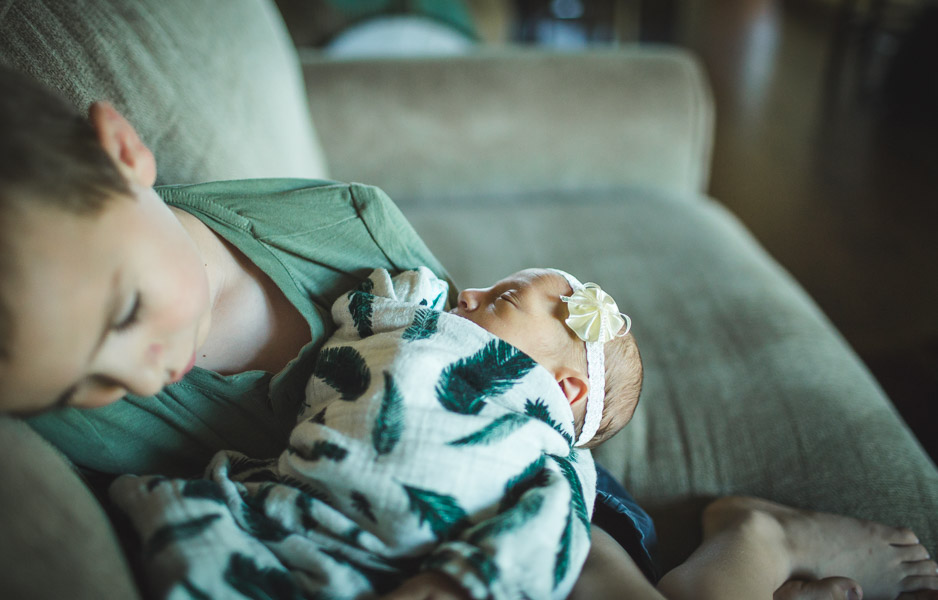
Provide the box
[452,269,642,448]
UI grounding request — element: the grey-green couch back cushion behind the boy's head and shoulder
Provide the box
[0,0,327,183]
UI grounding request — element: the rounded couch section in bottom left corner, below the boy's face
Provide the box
[0,416,139,600]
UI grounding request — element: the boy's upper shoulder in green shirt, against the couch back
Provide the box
[154,179,448,300]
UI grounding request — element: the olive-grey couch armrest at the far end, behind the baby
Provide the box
[301,46,714,202]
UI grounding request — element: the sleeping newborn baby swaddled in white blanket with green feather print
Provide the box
[288,268,642,598]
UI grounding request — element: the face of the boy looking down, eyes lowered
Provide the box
[0,185,211,414]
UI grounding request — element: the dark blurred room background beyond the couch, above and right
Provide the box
[281,0,938,459]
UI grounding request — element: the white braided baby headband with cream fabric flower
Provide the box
[551,269,632,446]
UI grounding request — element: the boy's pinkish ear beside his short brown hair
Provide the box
[88,101,156,187]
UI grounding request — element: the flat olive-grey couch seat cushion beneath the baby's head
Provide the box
[402,188,938,570]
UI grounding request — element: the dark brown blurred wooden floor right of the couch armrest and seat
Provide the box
[672,0,938,459]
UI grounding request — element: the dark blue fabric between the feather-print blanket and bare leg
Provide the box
[593,465,659,583]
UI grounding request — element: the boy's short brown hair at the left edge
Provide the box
[0,65,131,360]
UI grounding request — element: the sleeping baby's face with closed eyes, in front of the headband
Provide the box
[451,269,585,371]
